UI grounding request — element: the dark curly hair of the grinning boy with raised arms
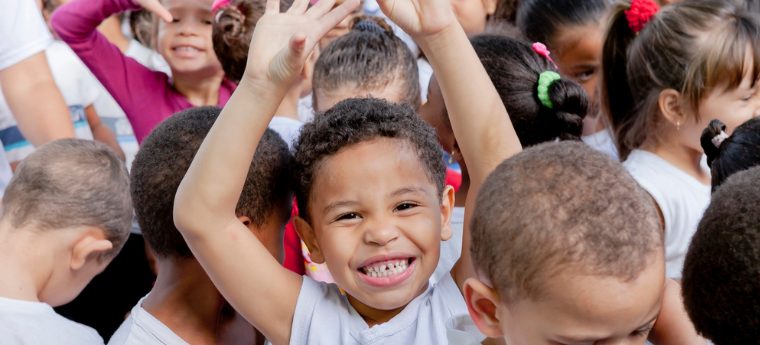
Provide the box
[295,98,446,220]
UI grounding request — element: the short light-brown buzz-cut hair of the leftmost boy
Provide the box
[2,139,132,257]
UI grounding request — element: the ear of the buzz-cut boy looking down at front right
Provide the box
[462,278,504,338]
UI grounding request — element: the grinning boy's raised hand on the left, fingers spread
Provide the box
[243,0,359,88]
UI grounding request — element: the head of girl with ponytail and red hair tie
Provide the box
[602,0,760,159]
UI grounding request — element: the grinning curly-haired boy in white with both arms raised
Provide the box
[175,0,520,344]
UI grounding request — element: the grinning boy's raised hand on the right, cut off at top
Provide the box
[377,0,458,38]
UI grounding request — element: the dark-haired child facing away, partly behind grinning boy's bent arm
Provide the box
[109,107,293,345]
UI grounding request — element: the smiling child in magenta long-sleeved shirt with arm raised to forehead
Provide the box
[51,0,235,143]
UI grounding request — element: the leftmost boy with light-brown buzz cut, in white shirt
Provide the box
[0,139,132,344]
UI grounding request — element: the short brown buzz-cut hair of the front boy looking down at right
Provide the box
[470,141,663,303]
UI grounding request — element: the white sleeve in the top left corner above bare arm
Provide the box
[0,0,53,70]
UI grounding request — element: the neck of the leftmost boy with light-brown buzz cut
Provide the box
[0,222,57,302]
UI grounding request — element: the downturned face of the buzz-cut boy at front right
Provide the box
[468,251,665,345]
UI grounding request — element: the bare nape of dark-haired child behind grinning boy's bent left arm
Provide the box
[142,258,256,344]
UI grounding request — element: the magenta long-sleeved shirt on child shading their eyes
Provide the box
[51,0,236,143]
